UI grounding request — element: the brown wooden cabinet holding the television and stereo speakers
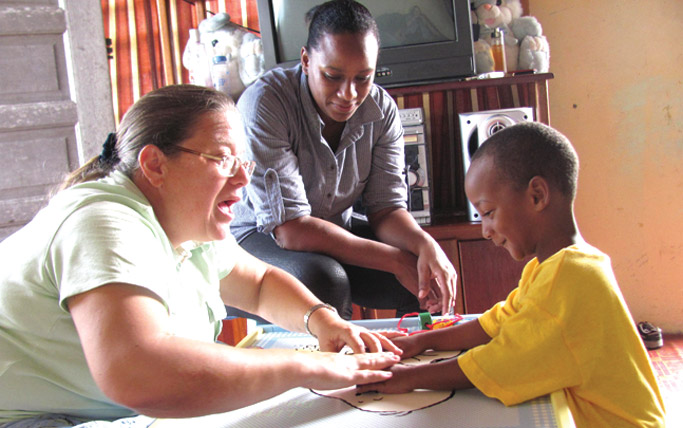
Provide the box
[389,73,553,313]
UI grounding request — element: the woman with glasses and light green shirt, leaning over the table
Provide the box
[0,85,400,427]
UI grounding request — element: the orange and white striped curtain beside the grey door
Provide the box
[101,0,259,124]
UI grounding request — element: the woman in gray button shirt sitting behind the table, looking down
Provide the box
[232,0,456,318]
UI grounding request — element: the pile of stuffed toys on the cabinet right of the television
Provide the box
[470,0,550,74]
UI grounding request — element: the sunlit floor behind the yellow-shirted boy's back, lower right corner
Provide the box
[648,334,683,428]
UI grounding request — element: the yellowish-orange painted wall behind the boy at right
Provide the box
[528,0,683,332]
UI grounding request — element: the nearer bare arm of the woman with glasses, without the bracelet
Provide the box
[68,284,398,417]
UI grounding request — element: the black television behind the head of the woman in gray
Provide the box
[257,0,475,88]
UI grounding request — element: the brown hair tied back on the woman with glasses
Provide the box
[61,85,236,189]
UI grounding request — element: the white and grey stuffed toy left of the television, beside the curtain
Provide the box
[183,13,265,100]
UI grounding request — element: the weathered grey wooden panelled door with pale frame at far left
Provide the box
[0,0,114,240]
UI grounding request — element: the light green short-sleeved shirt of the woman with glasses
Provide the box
[0,173,237,422]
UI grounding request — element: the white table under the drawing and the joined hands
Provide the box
[150,317,574,428]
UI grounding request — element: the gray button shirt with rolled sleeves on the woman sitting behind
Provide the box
[231,65,407,241]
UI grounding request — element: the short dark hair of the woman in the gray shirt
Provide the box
[306,0,380,51]
